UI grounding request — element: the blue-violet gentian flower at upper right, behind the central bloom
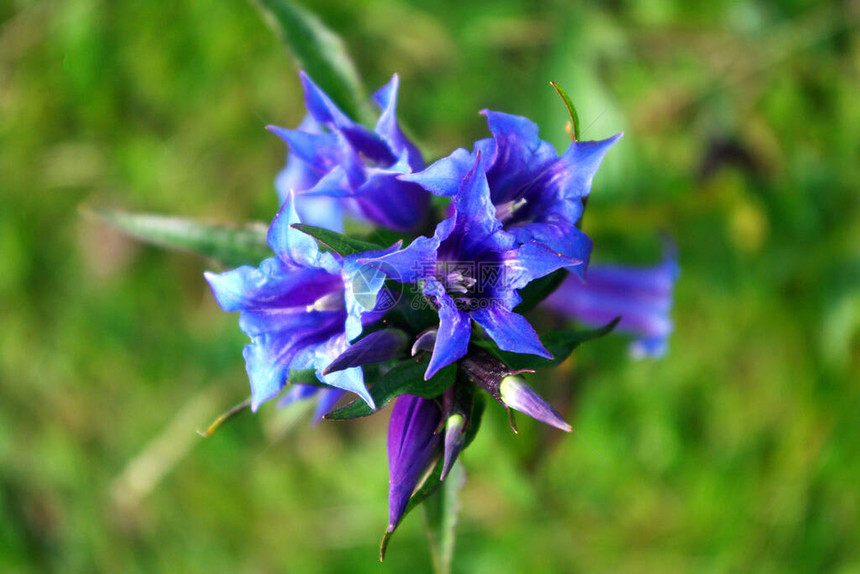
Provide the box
[400,110,621,274]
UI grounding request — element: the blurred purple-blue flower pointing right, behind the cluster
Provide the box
[543,247,679,358]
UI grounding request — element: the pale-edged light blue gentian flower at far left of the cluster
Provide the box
[205,195,399,410]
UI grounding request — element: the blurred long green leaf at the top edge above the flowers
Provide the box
[249,0,373,122]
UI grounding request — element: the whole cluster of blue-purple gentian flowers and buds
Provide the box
[206,74,677,552]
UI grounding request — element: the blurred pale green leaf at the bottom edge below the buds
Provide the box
[424,462,466,574]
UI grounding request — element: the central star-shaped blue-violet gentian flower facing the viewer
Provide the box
[359,153,582,379]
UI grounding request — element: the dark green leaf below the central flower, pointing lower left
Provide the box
[325,359,457,420]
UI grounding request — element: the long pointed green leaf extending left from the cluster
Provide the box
[84,209,273,267]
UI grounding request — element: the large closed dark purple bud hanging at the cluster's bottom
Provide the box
[388,395,442,532]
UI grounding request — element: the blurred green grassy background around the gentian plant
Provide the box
[0,0,860,573]
